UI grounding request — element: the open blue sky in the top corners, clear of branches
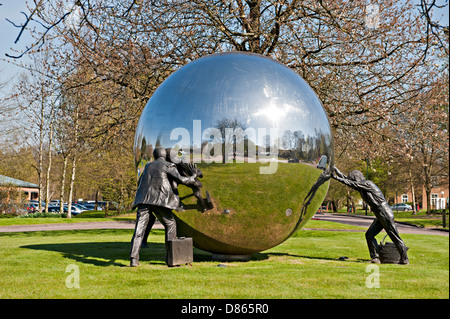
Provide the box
[0,0,449,91]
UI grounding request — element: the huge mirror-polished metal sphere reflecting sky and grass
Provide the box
[134,52,334,255]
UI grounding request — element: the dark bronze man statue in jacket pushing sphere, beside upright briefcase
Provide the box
[130,148,196,267]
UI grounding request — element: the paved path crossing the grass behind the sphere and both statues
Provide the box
[0,213,449,236]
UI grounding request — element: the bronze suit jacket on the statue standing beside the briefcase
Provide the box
[133,157,195,209]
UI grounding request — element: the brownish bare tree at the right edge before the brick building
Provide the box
[389,69,449,213]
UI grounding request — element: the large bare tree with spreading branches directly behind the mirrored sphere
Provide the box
[6,0,442,144]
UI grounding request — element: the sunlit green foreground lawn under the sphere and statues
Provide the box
[0,220,449,299]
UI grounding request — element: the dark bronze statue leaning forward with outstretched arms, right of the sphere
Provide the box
[332,167,409,265]
